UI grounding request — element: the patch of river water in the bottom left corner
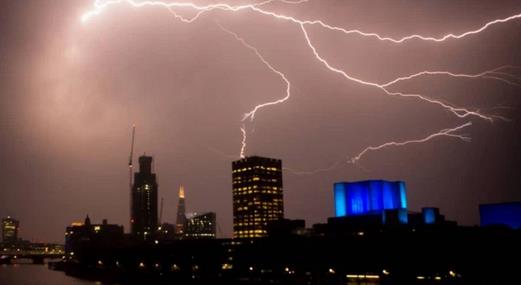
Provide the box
[0,264,97,285]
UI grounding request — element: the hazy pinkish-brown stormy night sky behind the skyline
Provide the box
[0,0,521,242]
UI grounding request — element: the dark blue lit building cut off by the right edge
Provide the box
[479,201,521,229]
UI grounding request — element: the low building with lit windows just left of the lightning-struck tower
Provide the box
[184,212,217,239]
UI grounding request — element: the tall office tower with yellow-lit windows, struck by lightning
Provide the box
[232,156,284,238]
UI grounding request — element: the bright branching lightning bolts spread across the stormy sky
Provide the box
[81,0,521,171]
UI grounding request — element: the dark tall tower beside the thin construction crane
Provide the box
[130,155,158,239]
